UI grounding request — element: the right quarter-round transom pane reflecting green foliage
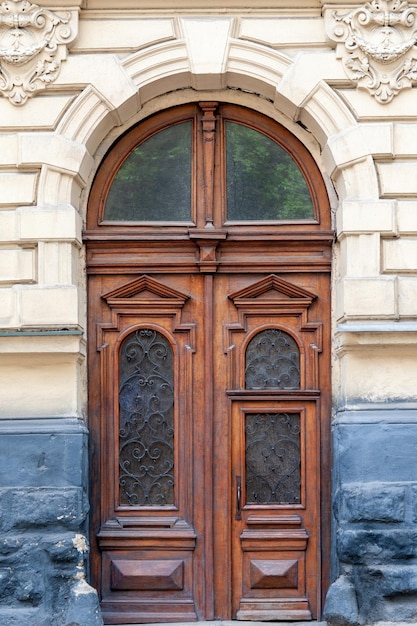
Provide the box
[226,122,314,221]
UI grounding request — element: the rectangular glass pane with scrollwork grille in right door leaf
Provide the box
[245,413,301,504]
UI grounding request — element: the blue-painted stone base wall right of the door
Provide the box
[325,410,417,626]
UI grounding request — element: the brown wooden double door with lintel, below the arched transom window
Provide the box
[85,101,331,624]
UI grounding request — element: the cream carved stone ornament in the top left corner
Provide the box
[0,0,78,105]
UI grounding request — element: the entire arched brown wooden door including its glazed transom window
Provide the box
[84,102,332,624]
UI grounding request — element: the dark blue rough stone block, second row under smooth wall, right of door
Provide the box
[338,528,417,564]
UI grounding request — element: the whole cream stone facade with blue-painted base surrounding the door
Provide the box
[0,0,417,626]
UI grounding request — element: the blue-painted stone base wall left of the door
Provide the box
[0,419,102,626]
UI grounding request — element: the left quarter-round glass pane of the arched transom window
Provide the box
[104,122,192,221]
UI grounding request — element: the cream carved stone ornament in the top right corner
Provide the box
[326,0,417,104]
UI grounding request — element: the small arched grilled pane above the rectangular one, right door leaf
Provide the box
[245,328,300,389]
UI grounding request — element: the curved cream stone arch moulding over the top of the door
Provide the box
[42,39,377,222]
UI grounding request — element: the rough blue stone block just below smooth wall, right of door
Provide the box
[338,483,406,523]
